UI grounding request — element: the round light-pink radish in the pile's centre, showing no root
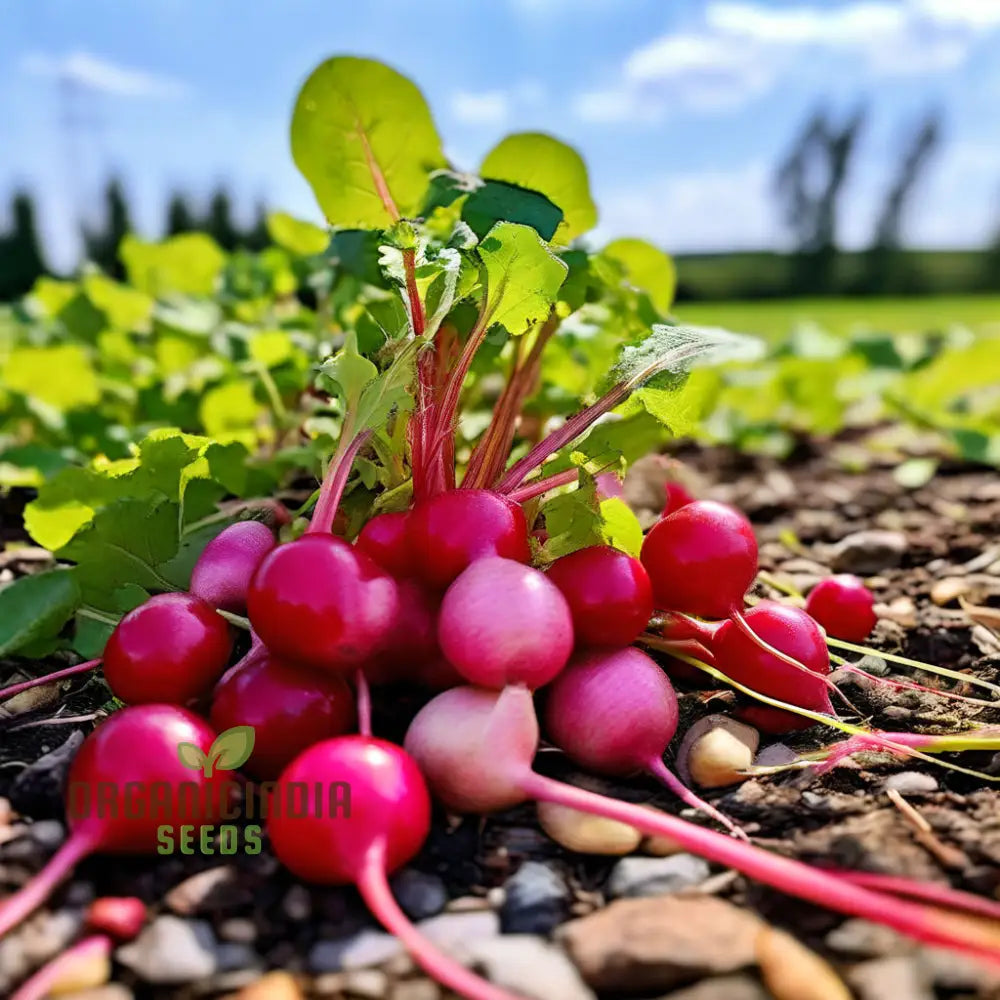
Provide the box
[438,558,573,688]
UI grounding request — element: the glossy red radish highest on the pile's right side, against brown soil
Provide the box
[640,500,757,618]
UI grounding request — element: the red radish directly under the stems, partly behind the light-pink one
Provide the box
[407,490,531,589]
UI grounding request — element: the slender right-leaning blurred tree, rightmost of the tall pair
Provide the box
[861,111,941,293]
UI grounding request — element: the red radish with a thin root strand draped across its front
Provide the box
[711,601,834,732]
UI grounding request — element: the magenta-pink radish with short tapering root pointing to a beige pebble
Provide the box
[545,646,742,835]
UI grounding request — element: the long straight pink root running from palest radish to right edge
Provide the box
[522,770,1000,966]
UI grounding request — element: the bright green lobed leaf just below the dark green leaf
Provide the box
[479,222,568,336]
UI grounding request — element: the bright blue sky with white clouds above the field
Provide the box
[0,0,1000,267]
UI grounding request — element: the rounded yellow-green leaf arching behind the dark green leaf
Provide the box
[479,132,597,243]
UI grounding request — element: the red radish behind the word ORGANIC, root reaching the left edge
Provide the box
[0,705,232,936]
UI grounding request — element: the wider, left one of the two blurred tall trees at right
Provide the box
[774,107,867,292]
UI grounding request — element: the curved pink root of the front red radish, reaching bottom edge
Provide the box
[357,842,521,1000]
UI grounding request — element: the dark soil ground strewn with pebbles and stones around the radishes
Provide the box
[0,440,1000,1000]
